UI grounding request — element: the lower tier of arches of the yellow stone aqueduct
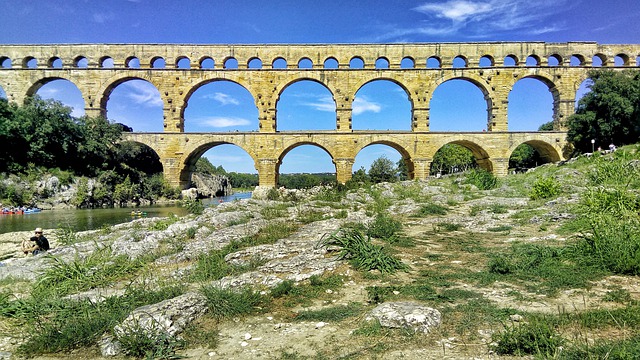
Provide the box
[123,131,571,188]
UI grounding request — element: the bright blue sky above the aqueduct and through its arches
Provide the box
[0,0,640,173]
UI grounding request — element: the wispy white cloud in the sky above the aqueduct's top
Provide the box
[378,0,579,40]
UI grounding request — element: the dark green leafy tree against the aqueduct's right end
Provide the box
[567,71,640,152]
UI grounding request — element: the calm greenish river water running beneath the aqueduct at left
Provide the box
[0,192,251,234]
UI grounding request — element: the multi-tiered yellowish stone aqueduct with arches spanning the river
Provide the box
[0,42,640,186]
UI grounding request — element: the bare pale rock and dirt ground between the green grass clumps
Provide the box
[0,165,640,359]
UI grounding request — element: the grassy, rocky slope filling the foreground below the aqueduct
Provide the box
[0,145,640,359]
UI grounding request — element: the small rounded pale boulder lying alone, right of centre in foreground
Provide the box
[366,302,442,334]
